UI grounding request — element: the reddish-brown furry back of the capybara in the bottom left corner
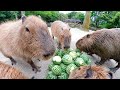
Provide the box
[0,61,28,79]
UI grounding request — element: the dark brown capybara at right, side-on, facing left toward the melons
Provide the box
[76,29,120,72]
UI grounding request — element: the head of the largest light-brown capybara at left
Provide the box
[19,16,55,60]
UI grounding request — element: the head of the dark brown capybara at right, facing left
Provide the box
[76,34,94,53]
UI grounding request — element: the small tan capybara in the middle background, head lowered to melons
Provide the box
[51,21,71,49]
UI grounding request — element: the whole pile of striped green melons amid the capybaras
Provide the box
[46,49,91,79]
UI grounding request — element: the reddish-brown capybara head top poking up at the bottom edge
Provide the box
[69,66,113,79]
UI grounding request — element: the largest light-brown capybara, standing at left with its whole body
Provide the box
[0,15,55,72]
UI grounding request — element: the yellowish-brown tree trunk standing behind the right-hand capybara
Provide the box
[82,11,91,31]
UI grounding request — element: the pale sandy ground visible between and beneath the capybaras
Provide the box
[0,28,120,79]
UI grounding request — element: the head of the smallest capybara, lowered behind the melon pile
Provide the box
[60,27,71,49]
